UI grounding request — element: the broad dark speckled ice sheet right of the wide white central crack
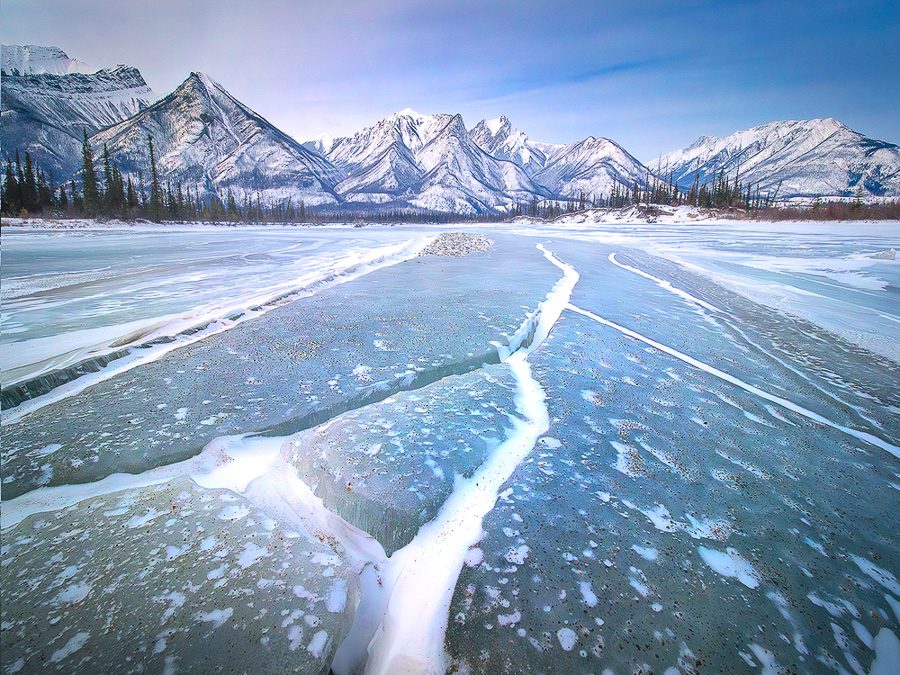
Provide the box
[448,236,900,672]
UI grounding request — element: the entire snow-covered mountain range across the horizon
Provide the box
[0,45,900,214]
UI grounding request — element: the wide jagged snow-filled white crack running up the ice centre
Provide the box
[342,244,579,673]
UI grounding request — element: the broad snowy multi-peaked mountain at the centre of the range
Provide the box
[313,108,549,213]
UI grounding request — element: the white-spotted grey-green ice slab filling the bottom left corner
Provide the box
[2,479,358,673]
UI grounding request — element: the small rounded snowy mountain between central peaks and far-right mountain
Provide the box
[534,136,649,198]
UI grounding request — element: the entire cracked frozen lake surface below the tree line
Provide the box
[2,222,900,673]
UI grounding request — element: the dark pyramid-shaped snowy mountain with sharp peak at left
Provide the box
[91,73,341,206]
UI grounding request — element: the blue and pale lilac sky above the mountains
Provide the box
[0,0,900,161]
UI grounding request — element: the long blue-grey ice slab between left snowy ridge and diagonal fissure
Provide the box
[3,236,557,497]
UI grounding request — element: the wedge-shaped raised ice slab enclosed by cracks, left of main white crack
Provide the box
[282,365,516,554]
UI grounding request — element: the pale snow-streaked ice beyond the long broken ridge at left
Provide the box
[0,227,428,387]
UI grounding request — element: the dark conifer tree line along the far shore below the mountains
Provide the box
[2,137,900,223]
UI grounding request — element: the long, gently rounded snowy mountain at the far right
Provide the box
[650,119,900,199]
